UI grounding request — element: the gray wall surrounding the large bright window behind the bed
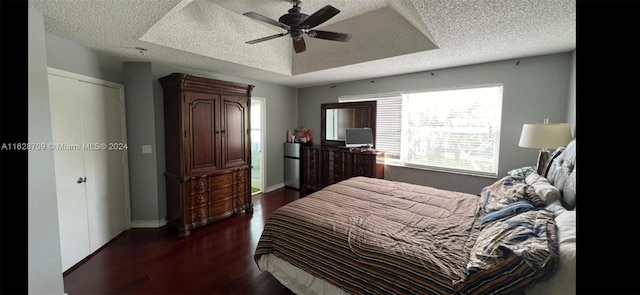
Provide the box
[298,53,575,194]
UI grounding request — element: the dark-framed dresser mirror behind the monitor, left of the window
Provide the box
[321,101,377,146]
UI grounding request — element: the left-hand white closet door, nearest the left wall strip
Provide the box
[49,75,91,271]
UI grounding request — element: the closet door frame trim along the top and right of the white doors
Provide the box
[47,67,131,230]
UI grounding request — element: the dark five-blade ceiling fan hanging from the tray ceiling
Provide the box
[243,0,351,53]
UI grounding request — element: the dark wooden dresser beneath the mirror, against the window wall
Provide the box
[302,146,384,190]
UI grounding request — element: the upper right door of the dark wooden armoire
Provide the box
[222,96,251,168]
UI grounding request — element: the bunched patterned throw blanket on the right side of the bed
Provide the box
[458,176,560,294]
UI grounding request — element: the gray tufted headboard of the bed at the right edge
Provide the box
[543,139,576,210]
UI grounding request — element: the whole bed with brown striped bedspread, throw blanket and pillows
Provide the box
[254,140,576,294]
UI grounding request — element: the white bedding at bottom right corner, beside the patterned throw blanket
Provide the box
[525,211,576,295]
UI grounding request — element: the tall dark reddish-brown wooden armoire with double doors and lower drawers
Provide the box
[158,73,254,237]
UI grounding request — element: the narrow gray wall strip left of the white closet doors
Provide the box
[27,9,64,294]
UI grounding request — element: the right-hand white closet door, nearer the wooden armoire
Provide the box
[79,82,126,252]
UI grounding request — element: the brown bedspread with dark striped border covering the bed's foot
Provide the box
[255,177,483,294]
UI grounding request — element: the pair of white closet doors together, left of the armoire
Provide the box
[49,71,130,272]
